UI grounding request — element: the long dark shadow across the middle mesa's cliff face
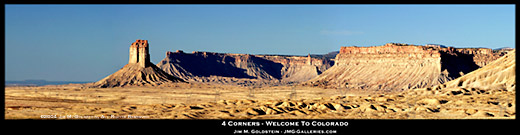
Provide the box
[164,52,283,79]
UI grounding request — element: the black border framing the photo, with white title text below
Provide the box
[2,0,519,134]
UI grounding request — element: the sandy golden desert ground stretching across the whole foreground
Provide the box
[5,84,516,119]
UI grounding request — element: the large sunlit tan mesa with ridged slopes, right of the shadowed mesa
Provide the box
[304,43,500,91]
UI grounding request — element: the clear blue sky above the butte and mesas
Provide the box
[5,5,515,81]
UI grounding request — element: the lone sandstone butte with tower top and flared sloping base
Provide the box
[89,39,184,88]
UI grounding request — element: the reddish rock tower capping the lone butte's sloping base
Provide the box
[128,39,151,67]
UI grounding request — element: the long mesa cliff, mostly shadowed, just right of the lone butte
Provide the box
[157,50,332,85]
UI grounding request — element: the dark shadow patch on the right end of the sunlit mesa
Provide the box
[440,51,480,79]
